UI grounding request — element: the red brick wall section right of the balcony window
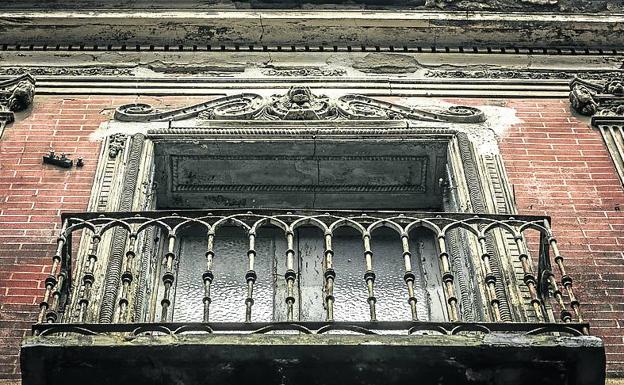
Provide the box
[500,100,624,376]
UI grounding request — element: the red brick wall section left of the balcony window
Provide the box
[0,96,189,381]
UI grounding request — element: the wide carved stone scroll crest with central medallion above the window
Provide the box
[115,86,486,123]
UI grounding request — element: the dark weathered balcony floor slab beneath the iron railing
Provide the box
[21,333,605,385]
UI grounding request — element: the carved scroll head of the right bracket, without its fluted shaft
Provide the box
[570,76,624,124]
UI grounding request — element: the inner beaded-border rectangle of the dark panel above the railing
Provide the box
[172,155,428,193]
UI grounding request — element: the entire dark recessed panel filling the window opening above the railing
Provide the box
[156,140,446,209]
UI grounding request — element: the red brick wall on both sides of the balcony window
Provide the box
[0,96,624,381]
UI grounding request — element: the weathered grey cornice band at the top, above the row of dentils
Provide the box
[0,10,624,50]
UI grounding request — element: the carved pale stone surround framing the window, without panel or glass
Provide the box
[66,88,533,322]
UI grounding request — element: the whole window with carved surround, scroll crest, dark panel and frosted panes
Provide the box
[61,88,531,328]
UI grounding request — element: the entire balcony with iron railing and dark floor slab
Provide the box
[22,210,604,385]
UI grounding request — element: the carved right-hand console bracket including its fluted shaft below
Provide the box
[570,77,624,183]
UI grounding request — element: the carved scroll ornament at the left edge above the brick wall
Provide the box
[0,74,35,138]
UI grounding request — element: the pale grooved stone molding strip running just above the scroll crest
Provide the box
[6,76,569,98]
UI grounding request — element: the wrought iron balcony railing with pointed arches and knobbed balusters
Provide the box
[33,210,588,335]
